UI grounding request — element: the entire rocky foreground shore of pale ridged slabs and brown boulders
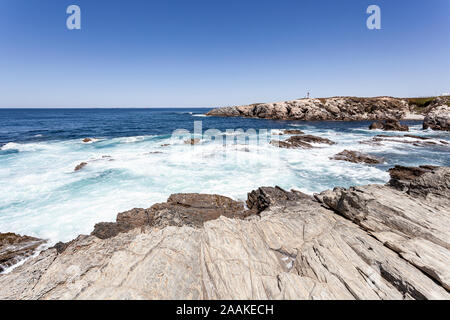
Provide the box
[0,165,450,299]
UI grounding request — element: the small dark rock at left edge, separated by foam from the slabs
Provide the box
[0,233,45,272]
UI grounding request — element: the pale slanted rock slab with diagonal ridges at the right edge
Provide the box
[316,166,450,290]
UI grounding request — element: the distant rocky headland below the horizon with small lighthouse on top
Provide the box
[206,96,450,131]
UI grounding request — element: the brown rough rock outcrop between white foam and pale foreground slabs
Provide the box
[92,194,252,239]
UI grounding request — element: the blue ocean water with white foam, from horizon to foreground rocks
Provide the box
[0,108,450,244]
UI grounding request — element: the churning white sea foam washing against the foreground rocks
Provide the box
[0,125,449,244]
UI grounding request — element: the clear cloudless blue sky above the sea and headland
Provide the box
[0,0,450,107]
